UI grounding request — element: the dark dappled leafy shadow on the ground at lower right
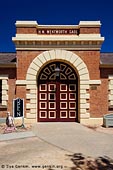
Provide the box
[68,153,113,170]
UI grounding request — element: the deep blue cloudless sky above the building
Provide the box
[0,0,113,52]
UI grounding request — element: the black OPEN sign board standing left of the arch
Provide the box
[13,98,24,118]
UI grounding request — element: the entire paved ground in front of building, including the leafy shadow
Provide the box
[0,123,113,170]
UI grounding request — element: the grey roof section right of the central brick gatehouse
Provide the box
[100,53,113,66]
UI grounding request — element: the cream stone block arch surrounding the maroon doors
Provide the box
[26,49,90,122]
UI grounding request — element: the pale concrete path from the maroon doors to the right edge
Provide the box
[33,123,113,158]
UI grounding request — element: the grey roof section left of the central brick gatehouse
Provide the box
[0,53,16,64]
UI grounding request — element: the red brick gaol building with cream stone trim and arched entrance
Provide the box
[0,21,113,124]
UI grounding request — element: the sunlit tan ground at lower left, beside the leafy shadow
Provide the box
[0,137,73,170]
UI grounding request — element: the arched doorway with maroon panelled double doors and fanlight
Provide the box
[37,62,78,122]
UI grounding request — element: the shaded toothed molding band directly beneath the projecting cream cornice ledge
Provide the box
[13,40,102,51]
